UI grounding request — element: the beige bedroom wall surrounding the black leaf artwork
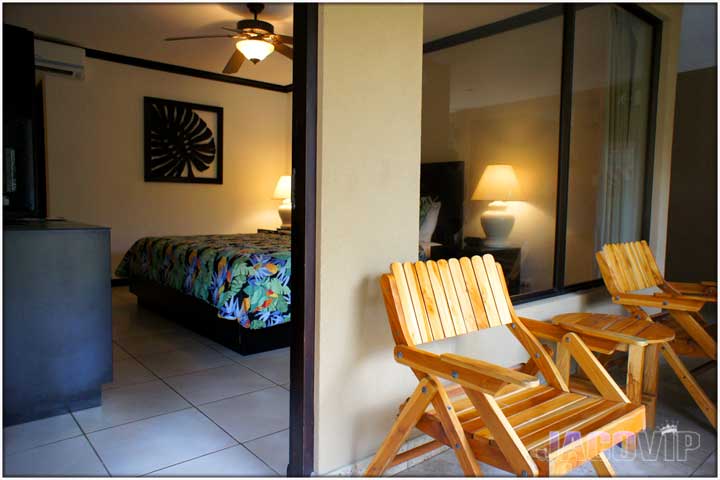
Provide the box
[40,59,291,268]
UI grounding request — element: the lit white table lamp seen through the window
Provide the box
[471,165,521,247]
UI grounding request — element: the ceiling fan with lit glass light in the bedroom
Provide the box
[165,3,293,73]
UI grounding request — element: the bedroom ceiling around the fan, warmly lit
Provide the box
[3,3,292,85]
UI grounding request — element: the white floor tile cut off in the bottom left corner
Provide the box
[3,436,107,477]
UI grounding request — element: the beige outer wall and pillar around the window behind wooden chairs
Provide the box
[316,1,681,474]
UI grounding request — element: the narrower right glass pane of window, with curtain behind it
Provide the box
[565,5,652,285]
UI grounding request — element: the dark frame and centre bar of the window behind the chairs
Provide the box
[423,3,663,305]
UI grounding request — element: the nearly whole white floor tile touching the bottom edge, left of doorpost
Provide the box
[88,409,236,476]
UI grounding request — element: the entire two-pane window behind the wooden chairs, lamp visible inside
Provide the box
[421,4,662,301]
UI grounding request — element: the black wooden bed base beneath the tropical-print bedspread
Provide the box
[130,277,290,355]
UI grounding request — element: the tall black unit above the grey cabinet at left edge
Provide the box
[2,24,47,220]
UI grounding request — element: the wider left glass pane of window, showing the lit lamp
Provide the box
[421,14,563,294]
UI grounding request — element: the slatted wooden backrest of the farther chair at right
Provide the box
[595,240,665,295]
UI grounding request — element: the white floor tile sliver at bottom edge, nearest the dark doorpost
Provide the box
[150,445,277,477]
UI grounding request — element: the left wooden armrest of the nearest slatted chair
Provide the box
[395,345,540,395]
